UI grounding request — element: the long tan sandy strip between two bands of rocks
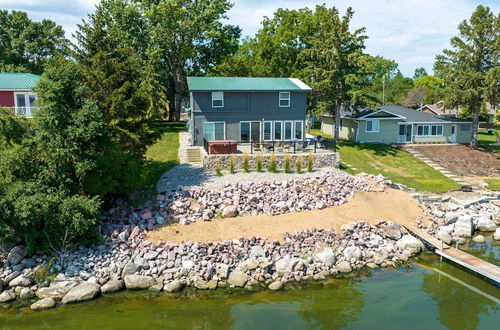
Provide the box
[146,189,425,242]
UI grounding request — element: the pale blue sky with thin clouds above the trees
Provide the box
[0,0,500,76]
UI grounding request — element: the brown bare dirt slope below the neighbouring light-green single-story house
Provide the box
[412,145,500,177]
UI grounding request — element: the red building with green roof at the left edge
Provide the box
[0,72,40,118]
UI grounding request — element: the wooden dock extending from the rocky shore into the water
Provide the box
[405,226,500,286]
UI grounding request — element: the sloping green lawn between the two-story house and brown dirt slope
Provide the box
[310,129,460,193]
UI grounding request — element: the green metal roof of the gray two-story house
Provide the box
[187,77,311,92]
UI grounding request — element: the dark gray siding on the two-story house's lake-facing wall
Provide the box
[191,91,307,145]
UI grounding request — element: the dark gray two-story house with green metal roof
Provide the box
[187,77,311,146]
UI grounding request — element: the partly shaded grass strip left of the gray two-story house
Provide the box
[142,122,186,192]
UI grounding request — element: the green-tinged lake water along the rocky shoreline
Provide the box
[0,246,500,330]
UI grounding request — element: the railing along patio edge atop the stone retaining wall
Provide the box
[203,138,336,155]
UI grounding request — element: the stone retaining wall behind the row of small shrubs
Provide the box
[203,151,340,172]
